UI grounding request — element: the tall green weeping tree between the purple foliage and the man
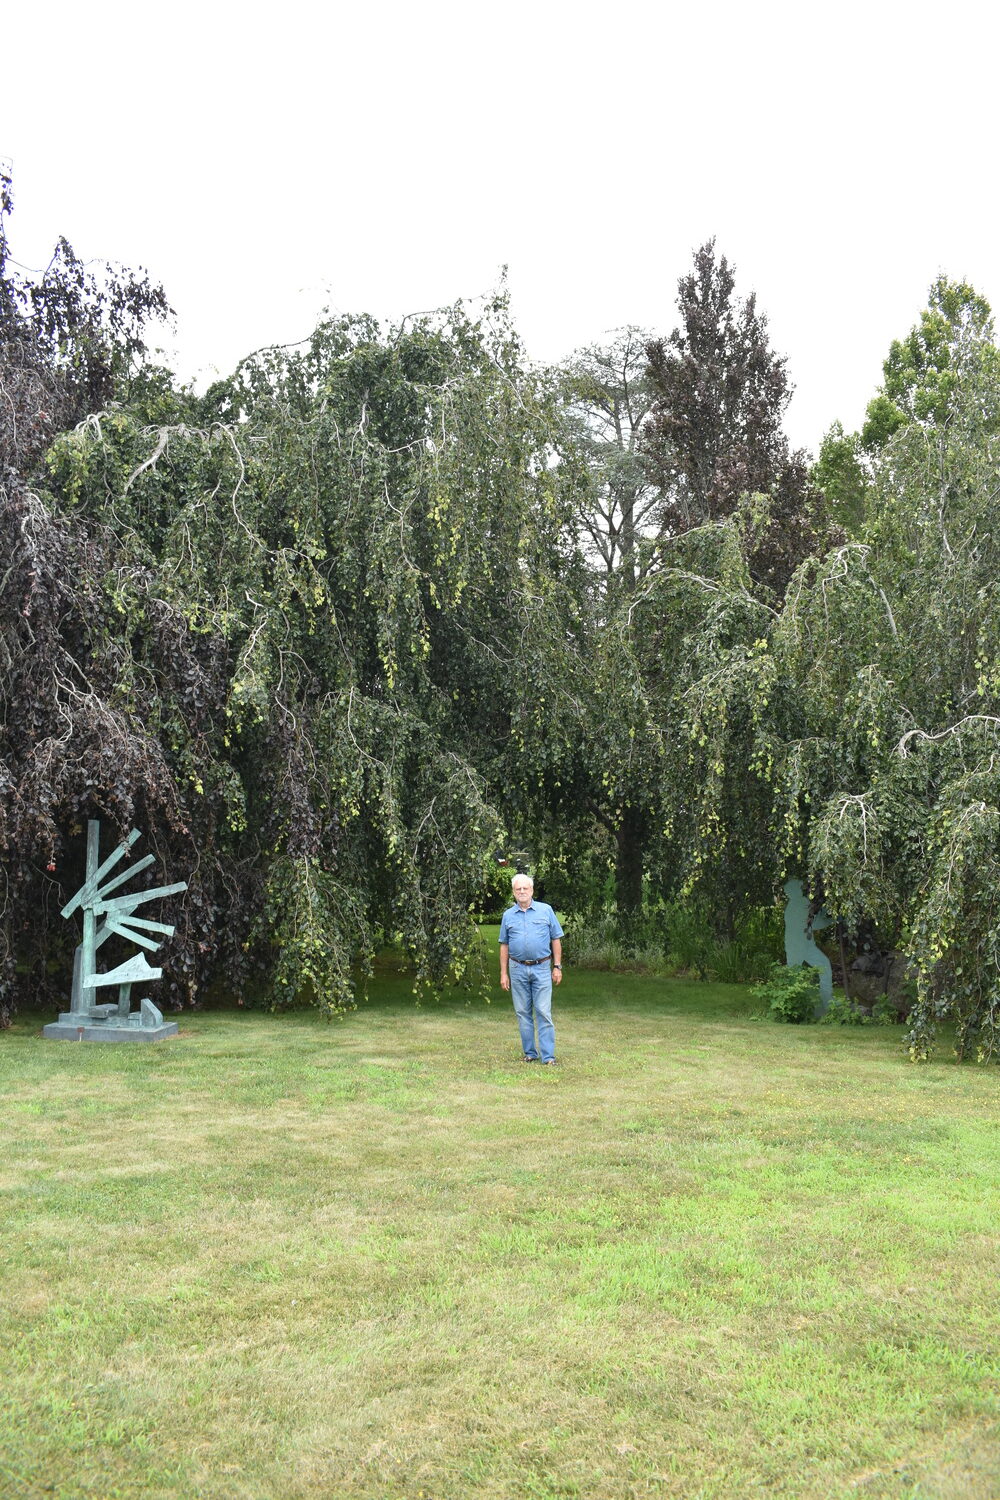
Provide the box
[68,302,569,1008]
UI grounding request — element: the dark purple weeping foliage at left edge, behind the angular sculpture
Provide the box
[0,174,177,1026]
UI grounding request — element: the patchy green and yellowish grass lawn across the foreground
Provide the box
[0,969,1000,1500]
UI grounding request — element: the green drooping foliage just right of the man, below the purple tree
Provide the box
[522,498,777,938]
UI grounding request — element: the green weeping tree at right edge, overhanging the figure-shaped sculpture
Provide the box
[671,284,1000,1059]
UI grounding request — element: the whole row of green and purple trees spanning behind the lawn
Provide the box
[7,170,1000,1056]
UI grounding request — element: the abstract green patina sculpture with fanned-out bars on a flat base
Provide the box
[42,819,187,1041]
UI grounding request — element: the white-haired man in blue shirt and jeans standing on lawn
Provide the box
[501,875,562,1068]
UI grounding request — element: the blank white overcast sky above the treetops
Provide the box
[0,0,1000,449]
